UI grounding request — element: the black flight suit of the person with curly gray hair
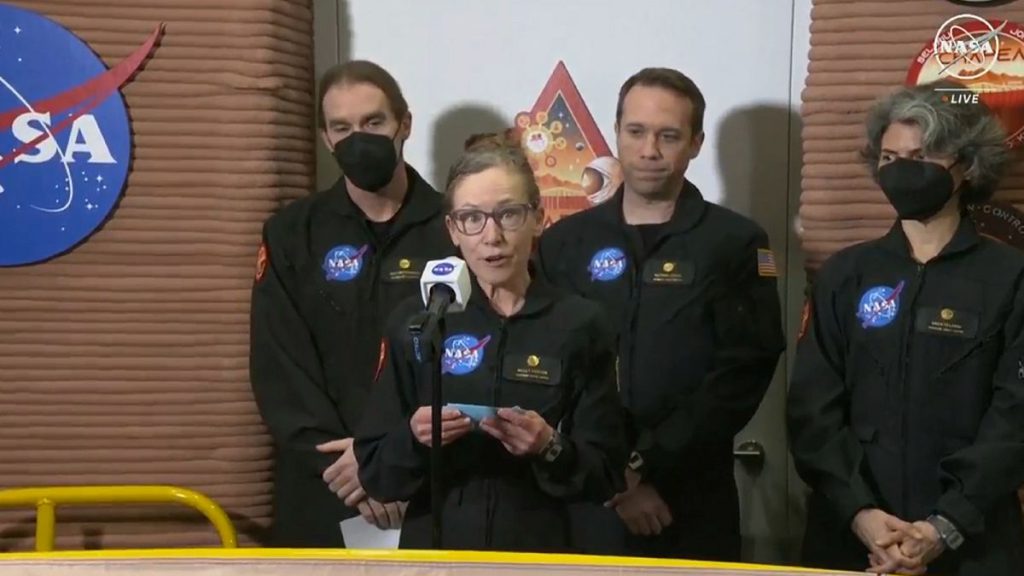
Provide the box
[788,217,1024,576]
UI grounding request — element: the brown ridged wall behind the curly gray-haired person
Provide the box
[800,0,1024,271]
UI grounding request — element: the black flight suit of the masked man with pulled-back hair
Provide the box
[250,168,455,547]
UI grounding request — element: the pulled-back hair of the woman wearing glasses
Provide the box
[444,130,541,210]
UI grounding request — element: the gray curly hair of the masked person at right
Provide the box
[861,80,1010,206]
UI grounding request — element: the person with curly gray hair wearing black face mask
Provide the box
[787,82,1024,576]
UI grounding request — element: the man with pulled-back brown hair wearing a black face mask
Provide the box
[250,60,455,547]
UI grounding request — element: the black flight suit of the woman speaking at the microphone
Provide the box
[355,272,626,552]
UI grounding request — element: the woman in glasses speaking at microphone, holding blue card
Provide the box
[355,132,626,552]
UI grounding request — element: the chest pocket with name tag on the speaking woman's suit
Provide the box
[501,354,568,416]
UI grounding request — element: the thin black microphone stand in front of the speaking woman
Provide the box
[409,300,450,550]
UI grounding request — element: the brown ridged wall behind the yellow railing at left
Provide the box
[0,0,314,550]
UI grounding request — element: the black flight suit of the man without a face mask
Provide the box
[540,181,785,561]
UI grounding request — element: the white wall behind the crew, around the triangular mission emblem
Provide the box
[319,0,793,209]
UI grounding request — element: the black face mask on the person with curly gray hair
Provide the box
[879,158,954,220]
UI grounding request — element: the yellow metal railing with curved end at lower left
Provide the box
[0,486,238,552]
